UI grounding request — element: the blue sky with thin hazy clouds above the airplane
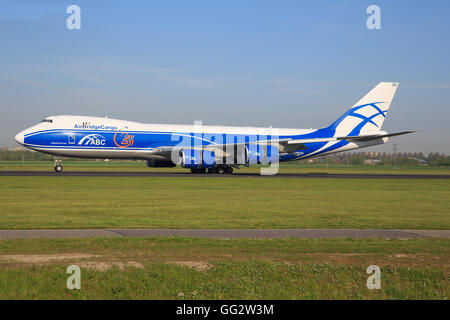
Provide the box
[0,0,450,154]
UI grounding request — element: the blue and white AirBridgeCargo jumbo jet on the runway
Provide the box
[15,82,414,173]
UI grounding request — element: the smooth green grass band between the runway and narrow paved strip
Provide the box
[0,176,450,229]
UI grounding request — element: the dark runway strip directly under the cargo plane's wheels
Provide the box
[0,171,450,179]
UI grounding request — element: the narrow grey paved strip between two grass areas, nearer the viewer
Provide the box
[0,229,450,240]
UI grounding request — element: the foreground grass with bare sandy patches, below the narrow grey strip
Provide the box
[0,237,450,299]
